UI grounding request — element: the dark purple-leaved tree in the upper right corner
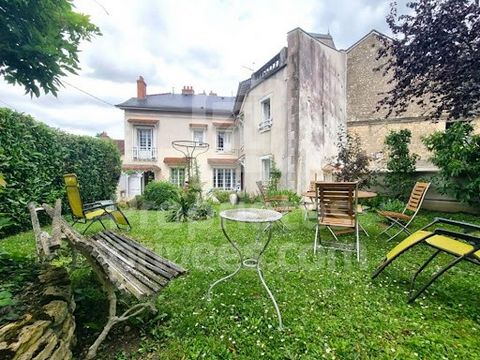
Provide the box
[378,0,480,120]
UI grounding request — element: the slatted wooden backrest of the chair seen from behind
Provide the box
[315,182,358,227]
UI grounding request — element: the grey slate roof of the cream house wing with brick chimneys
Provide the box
[116,93,235,115]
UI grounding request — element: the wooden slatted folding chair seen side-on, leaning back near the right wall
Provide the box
[378,182,430,241]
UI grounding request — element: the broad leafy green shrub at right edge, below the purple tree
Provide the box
[423,122,480,205]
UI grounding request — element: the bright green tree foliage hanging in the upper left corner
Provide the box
[0,0,101,96]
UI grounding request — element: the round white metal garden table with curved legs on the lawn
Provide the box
[207,208,283,329]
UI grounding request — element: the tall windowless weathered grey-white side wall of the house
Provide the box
[288,29,346,192]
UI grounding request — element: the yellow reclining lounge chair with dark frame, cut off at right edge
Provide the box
[372,218,480,302]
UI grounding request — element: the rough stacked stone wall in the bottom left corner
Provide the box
[0,266,75,360]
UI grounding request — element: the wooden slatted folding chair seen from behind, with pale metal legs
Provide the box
[313,182,360,261]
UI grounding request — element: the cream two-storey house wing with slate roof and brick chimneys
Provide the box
[117,77,236,198]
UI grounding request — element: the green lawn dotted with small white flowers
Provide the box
[0,210,480,359]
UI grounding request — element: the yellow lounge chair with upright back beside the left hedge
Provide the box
[63,174,132,233]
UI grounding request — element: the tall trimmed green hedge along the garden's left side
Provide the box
[0,108,121,236]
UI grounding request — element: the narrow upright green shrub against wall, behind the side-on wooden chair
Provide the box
[384,129,418,201]
